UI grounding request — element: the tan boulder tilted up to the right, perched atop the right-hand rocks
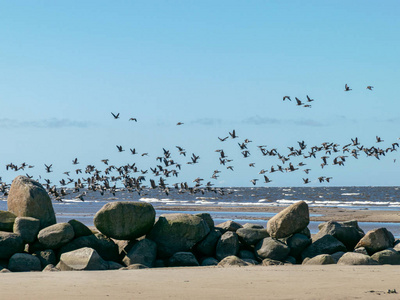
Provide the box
[267,201,310,239]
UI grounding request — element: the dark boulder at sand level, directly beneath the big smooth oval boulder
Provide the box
[122,239,157,268]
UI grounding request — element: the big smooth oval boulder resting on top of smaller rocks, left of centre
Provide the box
[93,201,156,240]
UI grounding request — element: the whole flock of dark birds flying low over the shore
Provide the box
[0,84,399,201]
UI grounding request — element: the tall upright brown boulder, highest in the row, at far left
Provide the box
[7,176,56,228]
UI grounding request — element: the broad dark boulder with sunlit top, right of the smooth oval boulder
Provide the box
[146,213,210,258]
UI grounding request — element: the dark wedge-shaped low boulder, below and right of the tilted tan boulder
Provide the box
[301,234,347,260]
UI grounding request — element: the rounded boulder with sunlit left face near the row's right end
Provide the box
[355,228,394,255]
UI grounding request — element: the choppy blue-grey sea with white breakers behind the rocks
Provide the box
[0,186,400,238]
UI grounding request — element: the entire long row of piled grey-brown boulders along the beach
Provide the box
[0,178,400,272]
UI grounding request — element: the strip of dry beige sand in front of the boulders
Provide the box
[0,265,400,299]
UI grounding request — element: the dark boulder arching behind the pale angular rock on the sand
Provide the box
[58,233,121,262]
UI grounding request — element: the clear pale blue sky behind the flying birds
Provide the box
[0,0,400,186]
